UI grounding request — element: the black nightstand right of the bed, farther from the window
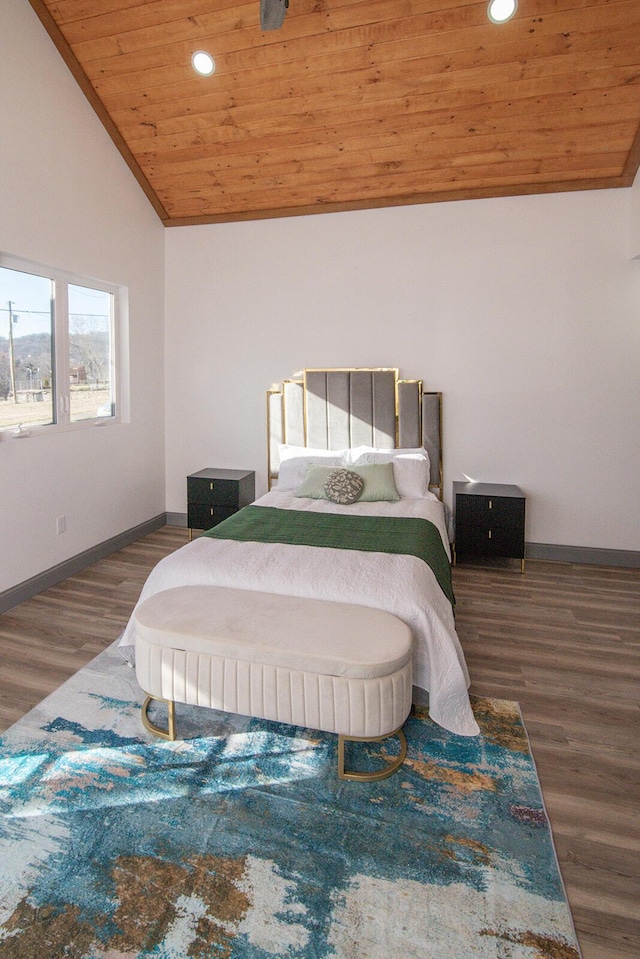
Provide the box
[453,483,525,573]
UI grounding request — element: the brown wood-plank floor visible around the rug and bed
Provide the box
[0,527,640,959]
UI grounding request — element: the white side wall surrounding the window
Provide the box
[0,0,165,591]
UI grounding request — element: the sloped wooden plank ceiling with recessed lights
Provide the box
[30,0,640,226]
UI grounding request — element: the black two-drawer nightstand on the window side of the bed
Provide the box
[187,469,256,539]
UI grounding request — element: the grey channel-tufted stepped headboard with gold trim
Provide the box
[267,368,442,499]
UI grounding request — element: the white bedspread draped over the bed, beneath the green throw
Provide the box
[120,490,478,736]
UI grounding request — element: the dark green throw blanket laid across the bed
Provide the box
[204,506,455,605]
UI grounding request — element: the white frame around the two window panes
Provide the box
[0,252,129,436]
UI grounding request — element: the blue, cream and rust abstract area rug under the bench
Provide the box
[0,647,580,959]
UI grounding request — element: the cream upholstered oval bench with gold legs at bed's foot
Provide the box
[134,586,412,781]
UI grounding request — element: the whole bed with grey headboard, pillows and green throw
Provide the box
[120,368,478,736]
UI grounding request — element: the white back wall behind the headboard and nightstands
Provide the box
[165,188,640,550]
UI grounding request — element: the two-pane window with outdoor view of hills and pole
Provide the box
[0,255,123,431]
